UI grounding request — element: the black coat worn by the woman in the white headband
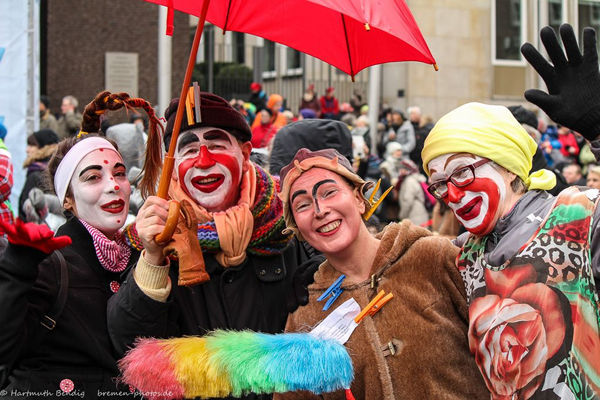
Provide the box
[0,218,139,399]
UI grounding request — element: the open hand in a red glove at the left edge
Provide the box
[0,218,71,254]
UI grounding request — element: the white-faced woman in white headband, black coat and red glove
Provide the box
[0,92,162,398]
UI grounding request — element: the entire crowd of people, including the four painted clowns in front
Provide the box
[0,21,600,400]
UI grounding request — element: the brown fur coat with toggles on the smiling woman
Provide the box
[274,221,490,400]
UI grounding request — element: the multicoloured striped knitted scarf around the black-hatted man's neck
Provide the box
[125,165,292,255]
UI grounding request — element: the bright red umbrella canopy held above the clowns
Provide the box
[146,0,435,77]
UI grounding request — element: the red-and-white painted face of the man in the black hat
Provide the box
[175,127,245,212]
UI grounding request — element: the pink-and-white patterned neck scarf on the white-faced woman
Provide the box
[79,219,131,272]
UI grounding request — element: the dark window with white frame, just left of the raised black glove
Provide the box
[492,0,526,65]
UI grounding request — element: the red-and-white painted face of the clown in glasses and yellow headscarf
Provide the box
[428,153,507,235]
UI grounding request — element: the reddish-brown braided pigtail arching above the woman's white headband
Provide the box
[78,91,164,198]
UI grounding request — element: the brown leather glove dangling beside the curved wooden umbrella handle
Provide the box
[164,200,210,286]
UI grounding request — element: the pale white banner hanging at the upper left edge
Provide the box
[0,0,39,214]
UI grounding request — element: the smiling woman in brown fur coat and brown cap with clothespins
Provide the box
[275,149,489,400]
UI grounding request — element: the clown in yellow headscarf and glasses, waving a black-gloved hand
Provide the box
[422,25,600,399]
